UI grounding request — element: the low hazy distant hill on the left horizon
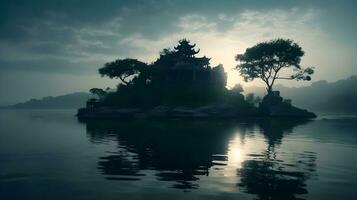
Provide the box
[7,92,93,109]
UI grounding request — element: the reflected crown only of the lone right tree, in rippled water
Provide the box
[238,152,316,199]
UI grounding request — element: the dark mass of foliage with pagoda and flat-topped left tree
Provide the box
[94,39,227,108]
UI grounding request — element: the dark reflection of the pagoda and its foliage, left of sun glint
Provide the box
[82,121,242,189]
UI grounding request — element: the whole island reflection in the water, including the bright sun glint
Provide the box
[80,120,316,199]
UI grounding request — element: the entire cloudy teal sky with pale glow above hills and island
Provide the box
[0,0,357,105]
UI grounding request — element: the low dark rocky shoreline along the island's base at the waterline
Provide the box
[77,101,316,119]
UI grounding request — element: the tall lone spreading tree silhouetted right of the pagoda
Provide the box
[236,39,314,94]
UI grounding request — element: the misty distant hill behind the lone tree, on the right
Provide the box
[244,76,357,113]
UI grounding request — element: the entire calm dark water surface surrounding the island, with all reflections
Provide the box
[0,110,357,200]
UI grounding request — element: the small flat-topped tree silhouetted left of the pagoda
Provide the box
[99,58,147,85]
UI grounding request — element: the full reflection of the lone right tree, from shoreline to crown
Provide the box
[238,120,316,200]
